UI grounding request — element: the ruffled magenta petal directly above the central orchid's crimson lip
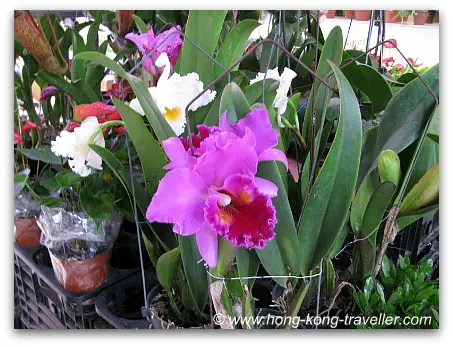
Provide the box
[195,130,258,187]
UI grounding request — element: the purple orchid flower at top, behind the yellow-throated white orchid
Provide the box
[125,25,182,77]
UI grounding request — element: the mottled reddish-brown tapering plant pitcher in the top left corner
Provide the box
[14,11,68,75]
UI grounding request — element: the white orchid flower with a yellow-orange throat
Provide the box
[129,53,216,136]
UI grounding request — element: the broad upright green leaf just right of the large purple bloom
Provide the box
[299,62,362,275]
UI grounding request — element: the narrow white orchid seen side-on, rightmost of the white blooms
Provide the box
[250,67,297,128]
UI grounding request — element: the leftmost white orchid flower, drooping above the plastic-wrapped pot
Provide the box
[51,117,105,177]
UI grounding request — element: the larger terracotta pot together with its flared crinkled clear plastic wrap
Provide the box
[38,206,122,292]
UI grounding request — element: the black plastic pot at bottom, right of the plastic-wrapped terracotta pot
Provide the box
[96,267,157,329]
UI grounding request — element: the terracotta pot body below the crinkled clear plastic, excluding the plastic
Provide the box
[49,250,112,293]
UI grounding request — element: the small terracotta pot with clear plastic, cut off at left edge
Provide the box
[14,192,41,247]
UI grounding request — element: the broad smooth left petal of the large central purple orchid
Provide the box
[146,168,207,235]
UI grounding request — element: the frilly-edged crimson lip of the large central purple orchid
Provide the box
[204,174,277,248]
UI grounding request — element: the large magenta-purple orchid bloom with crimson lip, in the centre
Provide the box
[146,108,288,267]
